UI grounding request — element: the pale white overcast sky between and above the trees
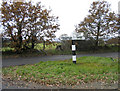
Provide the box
[0,0,120,37]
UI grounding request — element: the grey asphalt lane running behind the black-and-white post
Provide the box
[2,52,119,67]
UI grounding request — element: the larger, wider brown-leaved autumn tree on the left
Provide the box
[1,1,59,52]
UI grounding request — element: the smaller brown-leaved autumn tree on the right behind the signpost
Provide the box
[76,1,118,47]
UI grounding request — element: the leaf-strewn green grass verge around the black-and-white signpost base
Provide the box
[3,56,118,85]
